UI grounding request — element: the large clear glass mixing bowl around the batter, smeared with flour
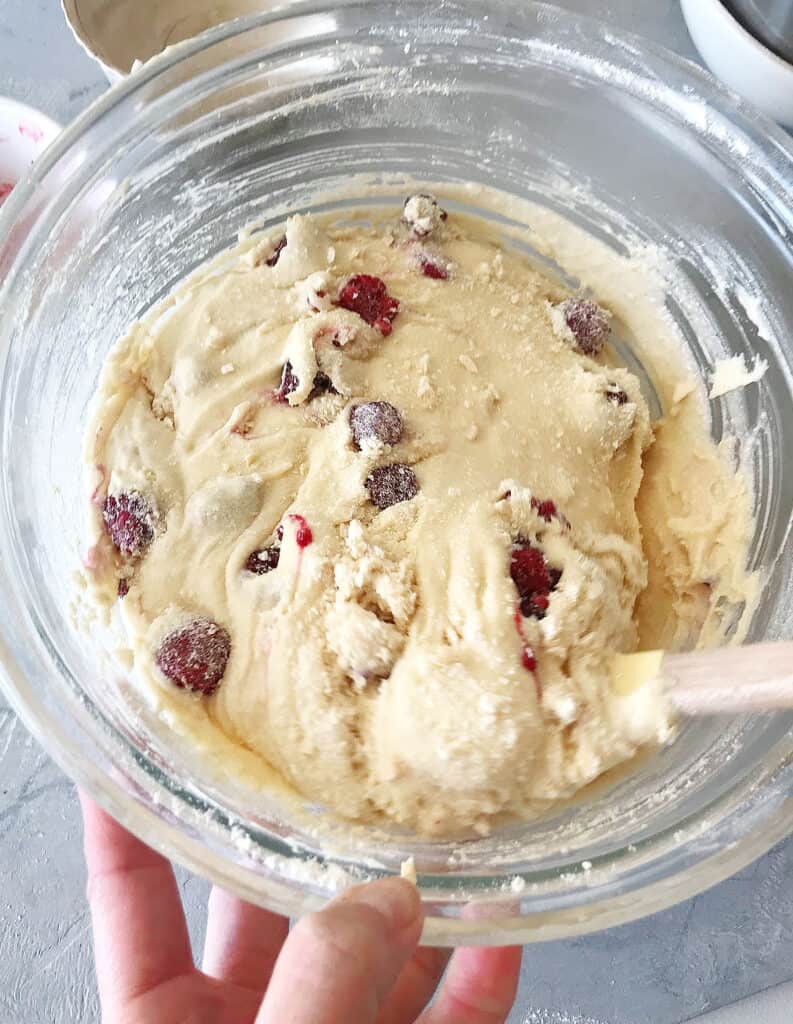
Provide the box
[0,0,793,944]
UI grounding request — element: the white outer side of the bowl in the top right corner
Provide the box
[681,0,793,128]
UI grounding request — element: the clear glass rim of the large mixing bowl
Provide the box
[0,0,793,945]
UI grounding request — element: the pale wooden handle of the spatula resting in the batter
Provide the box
[661,642,793,715]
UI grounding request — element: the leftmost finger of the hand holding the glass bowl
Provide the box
[80,793,194,1019]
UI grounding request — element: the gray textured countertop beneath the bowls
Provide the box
[0,0,793,1024]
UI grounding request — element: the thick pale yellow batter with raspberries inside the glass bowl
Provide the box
[86,194,750,836]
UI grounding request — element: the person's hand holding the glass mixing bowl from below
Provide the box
[80,795,520,1024]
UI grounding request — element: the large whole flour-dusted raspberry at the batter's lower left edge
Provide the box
[155,618,232,696]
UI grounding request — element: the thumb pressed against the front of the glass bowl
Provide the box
[256,879,422,1024]
